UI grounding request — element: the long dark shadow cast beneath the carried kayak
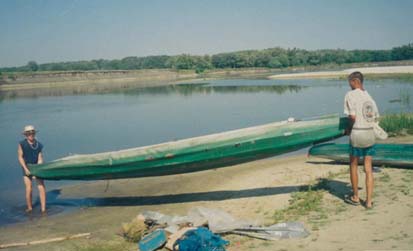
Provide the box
[0,179,351,225]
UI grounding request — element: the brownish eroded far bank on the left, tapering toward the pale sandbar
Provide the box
[0,68,273,91]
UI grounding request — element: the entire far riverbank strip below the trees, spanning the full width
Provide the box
[0,60,413,93]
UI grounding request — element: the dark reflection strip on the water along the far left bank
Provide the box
[0,83,306,102]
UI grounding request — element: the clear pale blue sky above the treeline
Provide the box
[0,0,413,67]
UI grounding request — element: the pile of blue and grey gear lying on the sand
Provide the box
[122,207,308,251]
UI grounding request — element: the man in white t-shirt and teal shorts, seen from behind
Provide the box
[344,72,379,209]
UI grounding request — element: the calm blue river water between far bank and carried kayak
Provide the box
[0,79,413,225]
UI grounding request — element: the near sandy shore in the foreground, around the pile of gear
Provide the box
[0,136,413,251]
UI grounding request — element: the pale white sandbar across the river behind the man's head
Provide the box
[268,65,413,79]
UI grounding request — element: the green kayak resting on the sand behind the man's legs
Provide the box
[309,143,413,168]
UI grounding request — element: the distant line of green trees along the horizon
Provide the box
[0,43,413,74]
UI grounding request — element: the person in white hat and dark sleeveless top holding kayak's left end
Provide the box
[17,125,46,214]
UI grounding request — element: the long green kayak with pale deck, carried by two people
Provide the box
[30,115,347,180]
